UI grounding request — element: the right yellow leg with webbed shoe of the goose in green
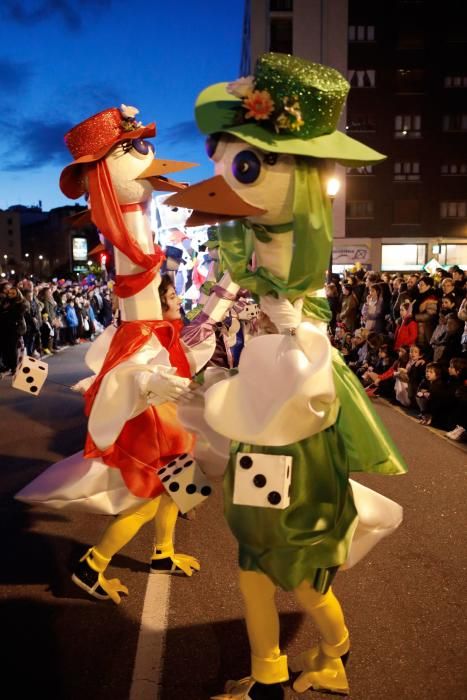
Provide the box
[289,581,350,694]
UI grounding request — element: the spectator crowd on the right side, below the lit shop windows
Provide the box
[326,266,467,442]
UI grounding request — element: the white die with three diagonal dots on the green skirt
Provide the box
[233,452,292,510]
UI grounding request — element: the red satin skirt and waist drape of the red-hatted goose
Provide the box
[84,320,194,498]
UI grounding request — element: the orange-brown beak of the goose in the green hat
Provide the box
[164,175,266,226]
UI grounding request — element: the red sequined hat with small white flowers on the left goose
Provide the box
[60,105,156,199]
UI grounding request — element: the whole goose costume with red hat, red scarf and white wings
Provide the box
[16,105,238,603]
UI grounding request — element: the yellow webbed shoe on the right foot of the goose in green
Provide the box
[289,646,349,695]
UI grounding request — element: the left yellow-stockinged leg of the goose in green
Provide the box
[240,571,289,684]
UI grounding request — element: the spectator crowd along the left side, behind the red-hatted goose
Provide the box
[0,279,114,375]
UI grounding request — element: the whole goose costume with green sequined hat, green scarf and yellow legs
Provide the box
[169,53,406,700]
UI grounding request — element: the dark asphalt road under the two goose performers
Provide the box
[0,346,467,700]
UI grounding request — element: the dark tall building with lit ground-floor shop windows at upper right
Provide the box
[242,0,467,271]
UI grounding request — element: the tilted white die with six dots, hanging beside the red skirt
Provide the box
[157,454,212,513]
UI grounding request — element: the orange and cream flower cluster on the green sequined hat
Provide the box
[227,75,305,133]
